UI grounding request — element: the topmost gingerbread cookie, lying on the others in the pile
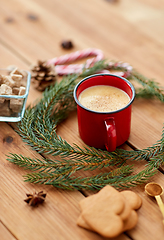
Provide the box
[79,185,125,237]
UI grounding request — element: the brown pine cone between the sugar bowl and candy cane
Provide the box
[31,60,57,91]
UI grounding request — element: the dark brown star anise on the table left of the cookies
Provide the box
[24,191,46,207]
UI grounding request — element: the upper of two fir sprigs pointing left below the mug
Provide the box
[7,145,125,174]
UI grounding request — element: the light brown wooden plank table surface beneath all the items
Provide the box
[0,0,164,240]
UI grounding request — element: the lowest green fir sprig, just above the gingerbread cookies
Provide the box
[24,166,132,190]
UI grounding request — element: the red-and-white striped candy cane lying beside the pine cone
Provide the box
[47,48,104,75]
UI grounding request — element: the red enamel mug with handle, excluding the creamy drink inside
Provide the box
[74,74,135,152]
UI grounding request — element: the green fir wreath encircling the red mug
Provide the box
[7,61,164,190]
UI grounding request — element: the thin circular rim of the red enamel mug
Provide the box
[73,73,135,114]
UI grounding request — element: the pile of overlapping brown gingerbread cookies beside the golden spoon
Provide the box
[77,185,142,238]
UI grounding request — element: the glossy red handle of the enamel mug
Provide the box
[104,117,117,152]
